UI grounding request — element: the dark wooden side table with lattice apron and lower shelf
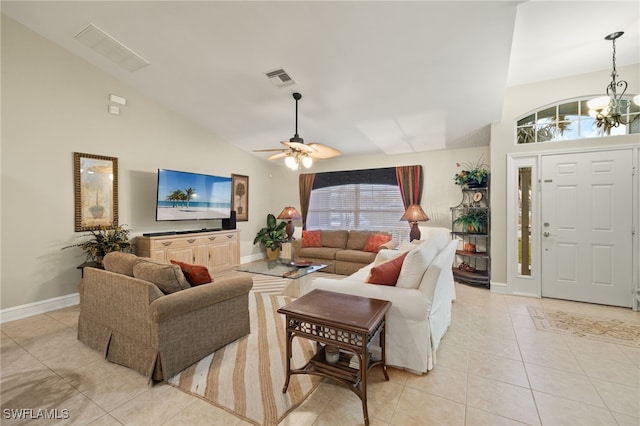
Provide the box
[278,290,391,425]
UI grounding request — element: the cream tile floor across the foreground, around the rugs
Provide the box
[0,285,640,426]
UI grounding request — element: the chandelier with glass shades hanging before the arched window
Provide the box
[587,31,640,133]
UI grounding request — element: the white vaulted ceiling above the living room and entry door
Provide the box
[1,0,640,158]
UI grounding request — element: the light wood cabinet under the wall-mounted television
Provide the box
[136,229,240,272]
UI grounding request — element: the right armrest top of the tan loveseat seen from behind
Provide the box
[150,276,253,323]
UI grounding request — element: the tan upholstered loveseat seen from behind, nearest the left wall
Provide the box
[78,253,253,381]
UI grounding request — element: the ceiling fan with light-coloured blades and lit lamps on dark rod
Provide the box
[253,92,341,170]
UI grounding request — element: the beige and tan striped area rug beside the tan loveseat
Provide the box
[168,292,320,425]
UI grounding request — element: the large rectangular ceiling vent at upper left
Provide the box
[73,24,149,72]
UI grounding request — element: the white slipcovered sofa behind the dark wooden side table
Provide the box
[312,228,458,374]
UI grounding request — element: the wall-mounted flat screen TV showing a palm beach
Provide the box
[156,169,231,221]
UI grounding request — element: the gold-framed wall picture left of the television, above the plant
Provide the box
[73,152,118,232]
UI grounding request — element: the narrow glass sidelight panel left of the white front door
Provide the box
[518,167,532,276]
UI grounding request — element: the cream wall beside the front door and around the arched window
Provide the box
[491,64,640,283]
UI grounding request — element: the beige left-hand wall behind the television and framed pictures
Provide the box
[0,16,278,308]
